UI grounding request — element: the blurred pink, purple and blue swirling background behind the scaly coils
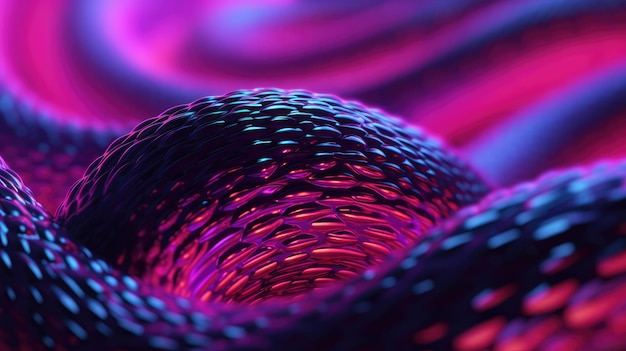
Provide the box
[0,0,626,211]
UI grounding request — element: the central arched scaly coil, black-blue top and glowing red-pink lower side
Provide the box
[58,89,487,303]
